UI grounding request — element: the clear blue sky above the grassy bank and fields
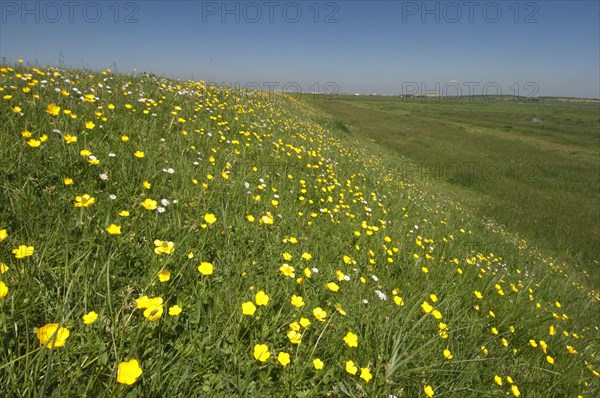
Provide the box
[0,0,600,98]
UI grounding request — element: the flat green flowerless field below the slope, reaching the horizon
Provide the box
[305,96,600,288]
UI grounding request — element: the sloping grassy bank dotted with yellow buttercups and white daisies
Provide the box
[0,65,600,398]
